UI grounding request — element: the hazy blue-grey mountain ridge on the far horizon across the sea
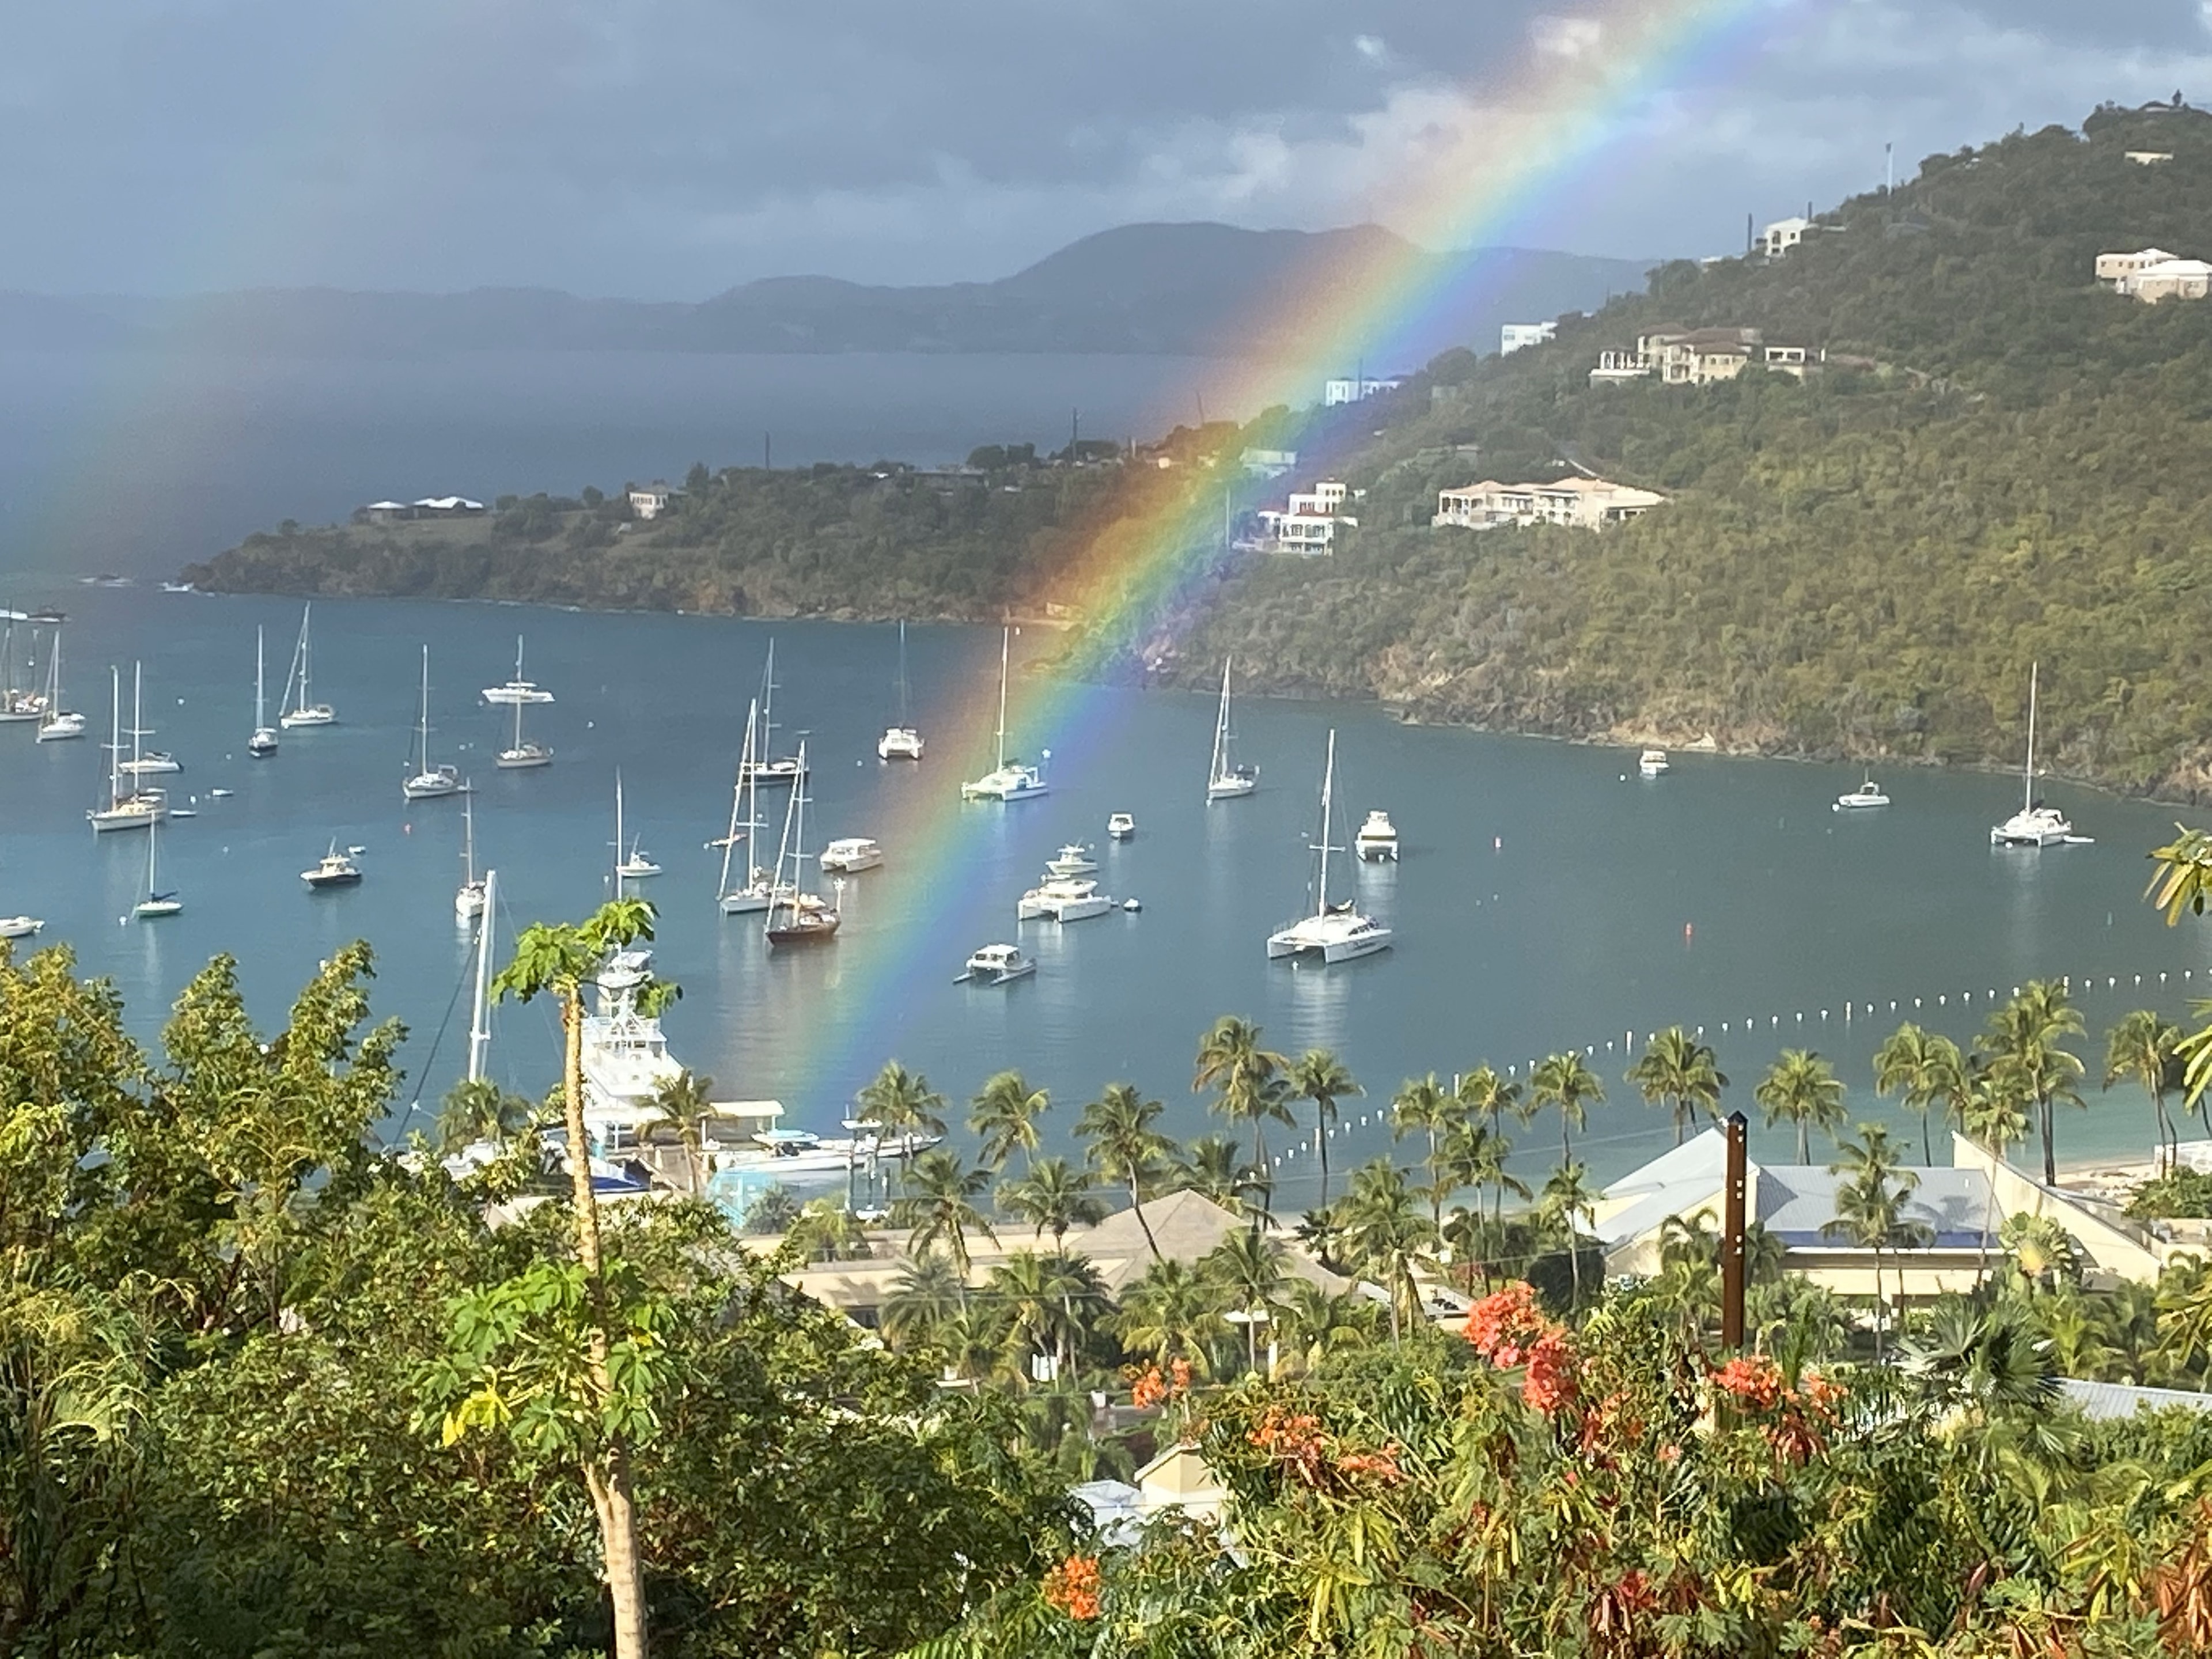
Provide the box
[0,224,1654,367]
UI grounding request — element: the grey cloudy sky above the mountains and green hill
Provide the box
[13,0,2212,298]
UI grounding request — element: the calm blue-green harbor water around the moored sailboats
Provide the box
[0,586,2212,1201]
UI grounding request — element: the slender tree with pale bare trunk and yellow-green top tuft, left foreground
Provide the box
[493,898,681,1659]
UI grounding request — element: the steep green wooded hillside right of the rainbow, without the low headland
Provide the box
[1119,111,2212,798]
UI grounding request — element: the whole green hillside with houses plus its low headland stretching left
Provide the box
[190,106,2212,801]
